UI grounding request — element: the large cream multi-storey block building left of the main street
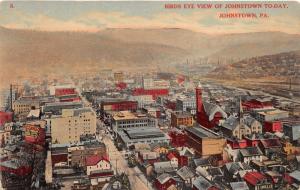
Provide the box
[48,108,96,144]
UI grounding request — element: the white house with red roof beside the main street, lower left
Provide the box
[86,155,111,175]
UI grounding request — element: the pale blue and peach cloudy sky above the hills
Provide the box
[0,1,300,34]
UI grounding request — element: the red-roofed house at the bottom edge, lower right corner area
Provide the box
[244,171,273,190]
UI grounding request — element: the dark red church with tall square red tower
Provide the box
[196,87,227,129]
